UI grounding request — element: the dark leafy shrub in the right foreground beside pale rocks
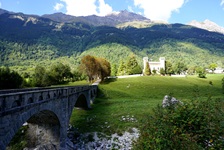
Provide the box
[135,99,224,149]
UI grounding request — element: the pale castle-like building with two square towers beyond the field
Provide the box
[143,57,165,72]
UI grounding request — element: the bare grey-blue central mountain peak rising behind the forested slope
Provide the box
[42,10,151,26]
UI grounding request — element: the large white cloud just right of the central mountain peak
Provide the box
[134,0,188,22]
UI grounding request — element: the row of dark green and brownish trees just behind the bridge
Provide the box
[0,55,111,89]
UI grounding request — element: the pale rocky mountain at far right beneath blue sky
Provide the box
[188,19,224,34]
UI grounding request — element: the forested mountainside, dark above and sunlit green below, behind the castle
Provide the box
[0,8,224,72]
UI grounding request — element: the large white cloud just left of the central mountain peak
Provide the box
[61,0,113,16]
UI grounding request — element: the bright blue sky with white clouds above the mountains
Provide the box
[0,0,224,27]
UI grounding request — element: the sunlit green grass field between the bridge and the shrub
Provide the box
[70,75,224,134]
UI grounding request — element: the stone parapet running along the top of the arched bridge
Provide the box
[0,85,97,117]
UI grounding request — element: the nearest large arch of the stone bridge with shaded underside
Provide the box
[5,109,64,149]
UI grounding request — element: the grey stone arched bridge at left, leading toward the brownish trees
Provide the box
[0,85,97,150]
